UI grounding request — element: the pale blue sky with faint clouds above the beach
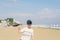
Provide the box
[0,0,60,24]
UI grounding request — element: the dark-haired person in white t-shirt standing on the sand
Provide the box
[18,20,34,40]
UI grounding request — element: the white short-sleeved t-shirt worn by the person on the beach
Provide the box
[20,27,34,40]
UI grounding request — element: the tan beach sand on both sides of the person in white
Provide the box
[0,27,60,40]
